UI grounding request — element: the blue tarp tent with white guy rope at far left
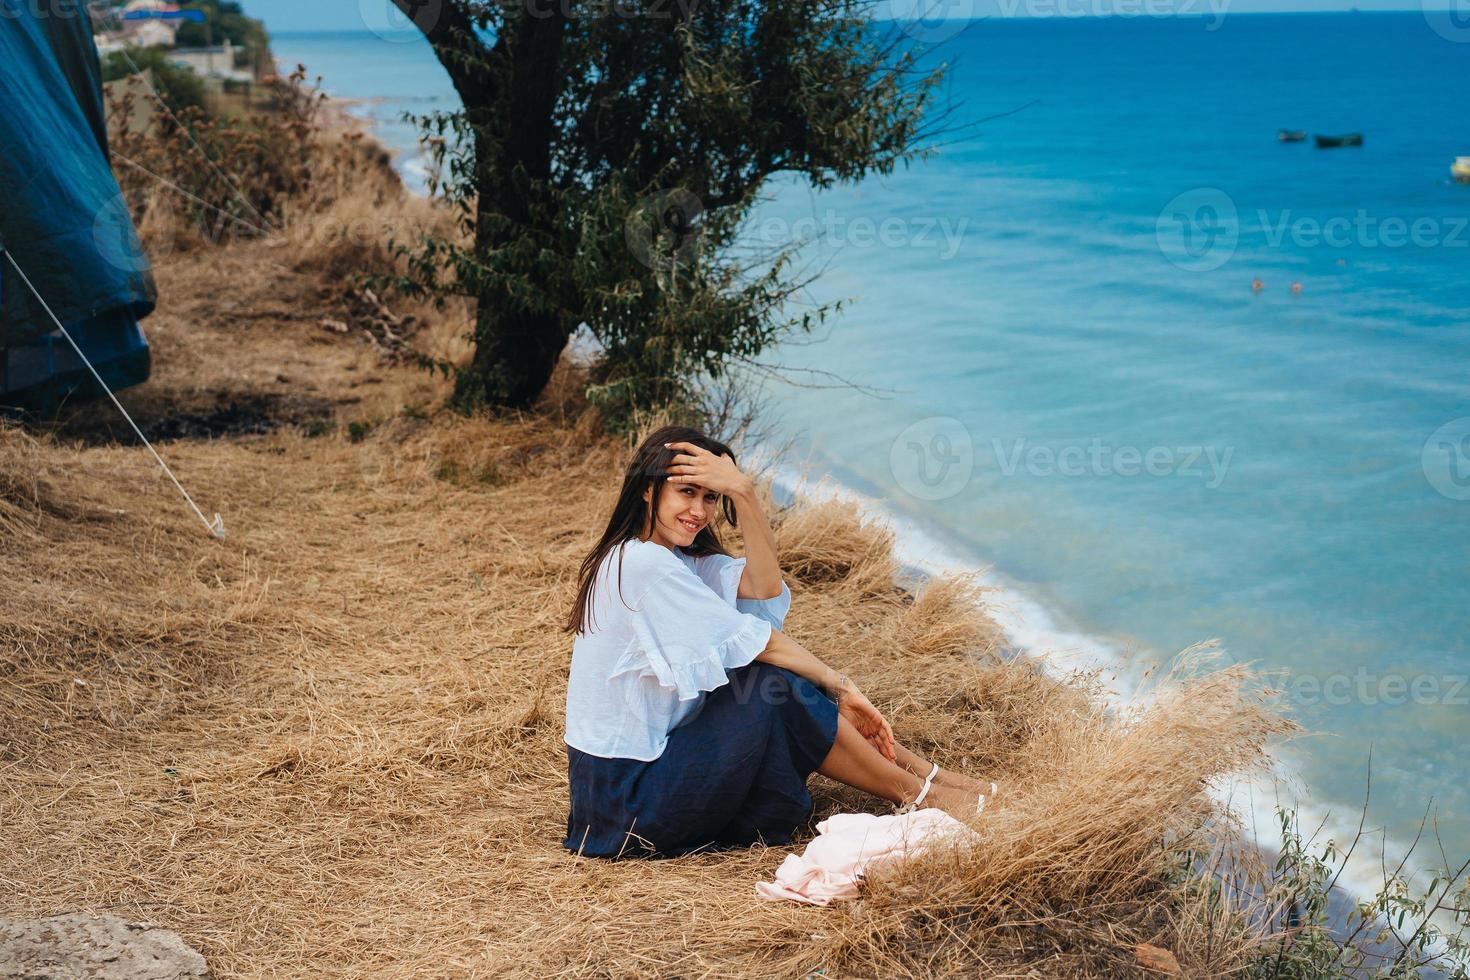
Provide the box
[0,0,157,410]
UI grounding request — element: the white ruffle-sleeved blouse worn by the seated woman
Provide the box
[564,538,791,763]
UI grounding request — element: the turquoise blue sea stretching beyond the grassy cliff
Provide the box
[275,12,1470,862]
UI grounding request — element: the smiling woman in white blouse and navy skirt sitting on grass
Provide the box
[562,426,994,858]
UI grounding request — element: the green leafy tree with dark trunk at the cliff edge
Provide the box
[391,0,939,419]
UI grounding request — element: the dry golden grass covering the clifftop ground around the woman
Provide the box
[0,153,1285,977]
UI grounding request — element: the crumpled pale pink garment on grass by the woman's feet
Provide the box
[756,807,975,905]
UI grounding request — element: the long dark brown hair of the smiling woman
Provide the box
[563,426,736,633]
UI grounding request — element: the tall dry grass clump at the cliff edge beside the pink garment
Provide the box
[841,651,1291,976]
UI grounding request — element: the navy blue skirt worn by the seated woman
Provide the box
[562,661,836,858]
